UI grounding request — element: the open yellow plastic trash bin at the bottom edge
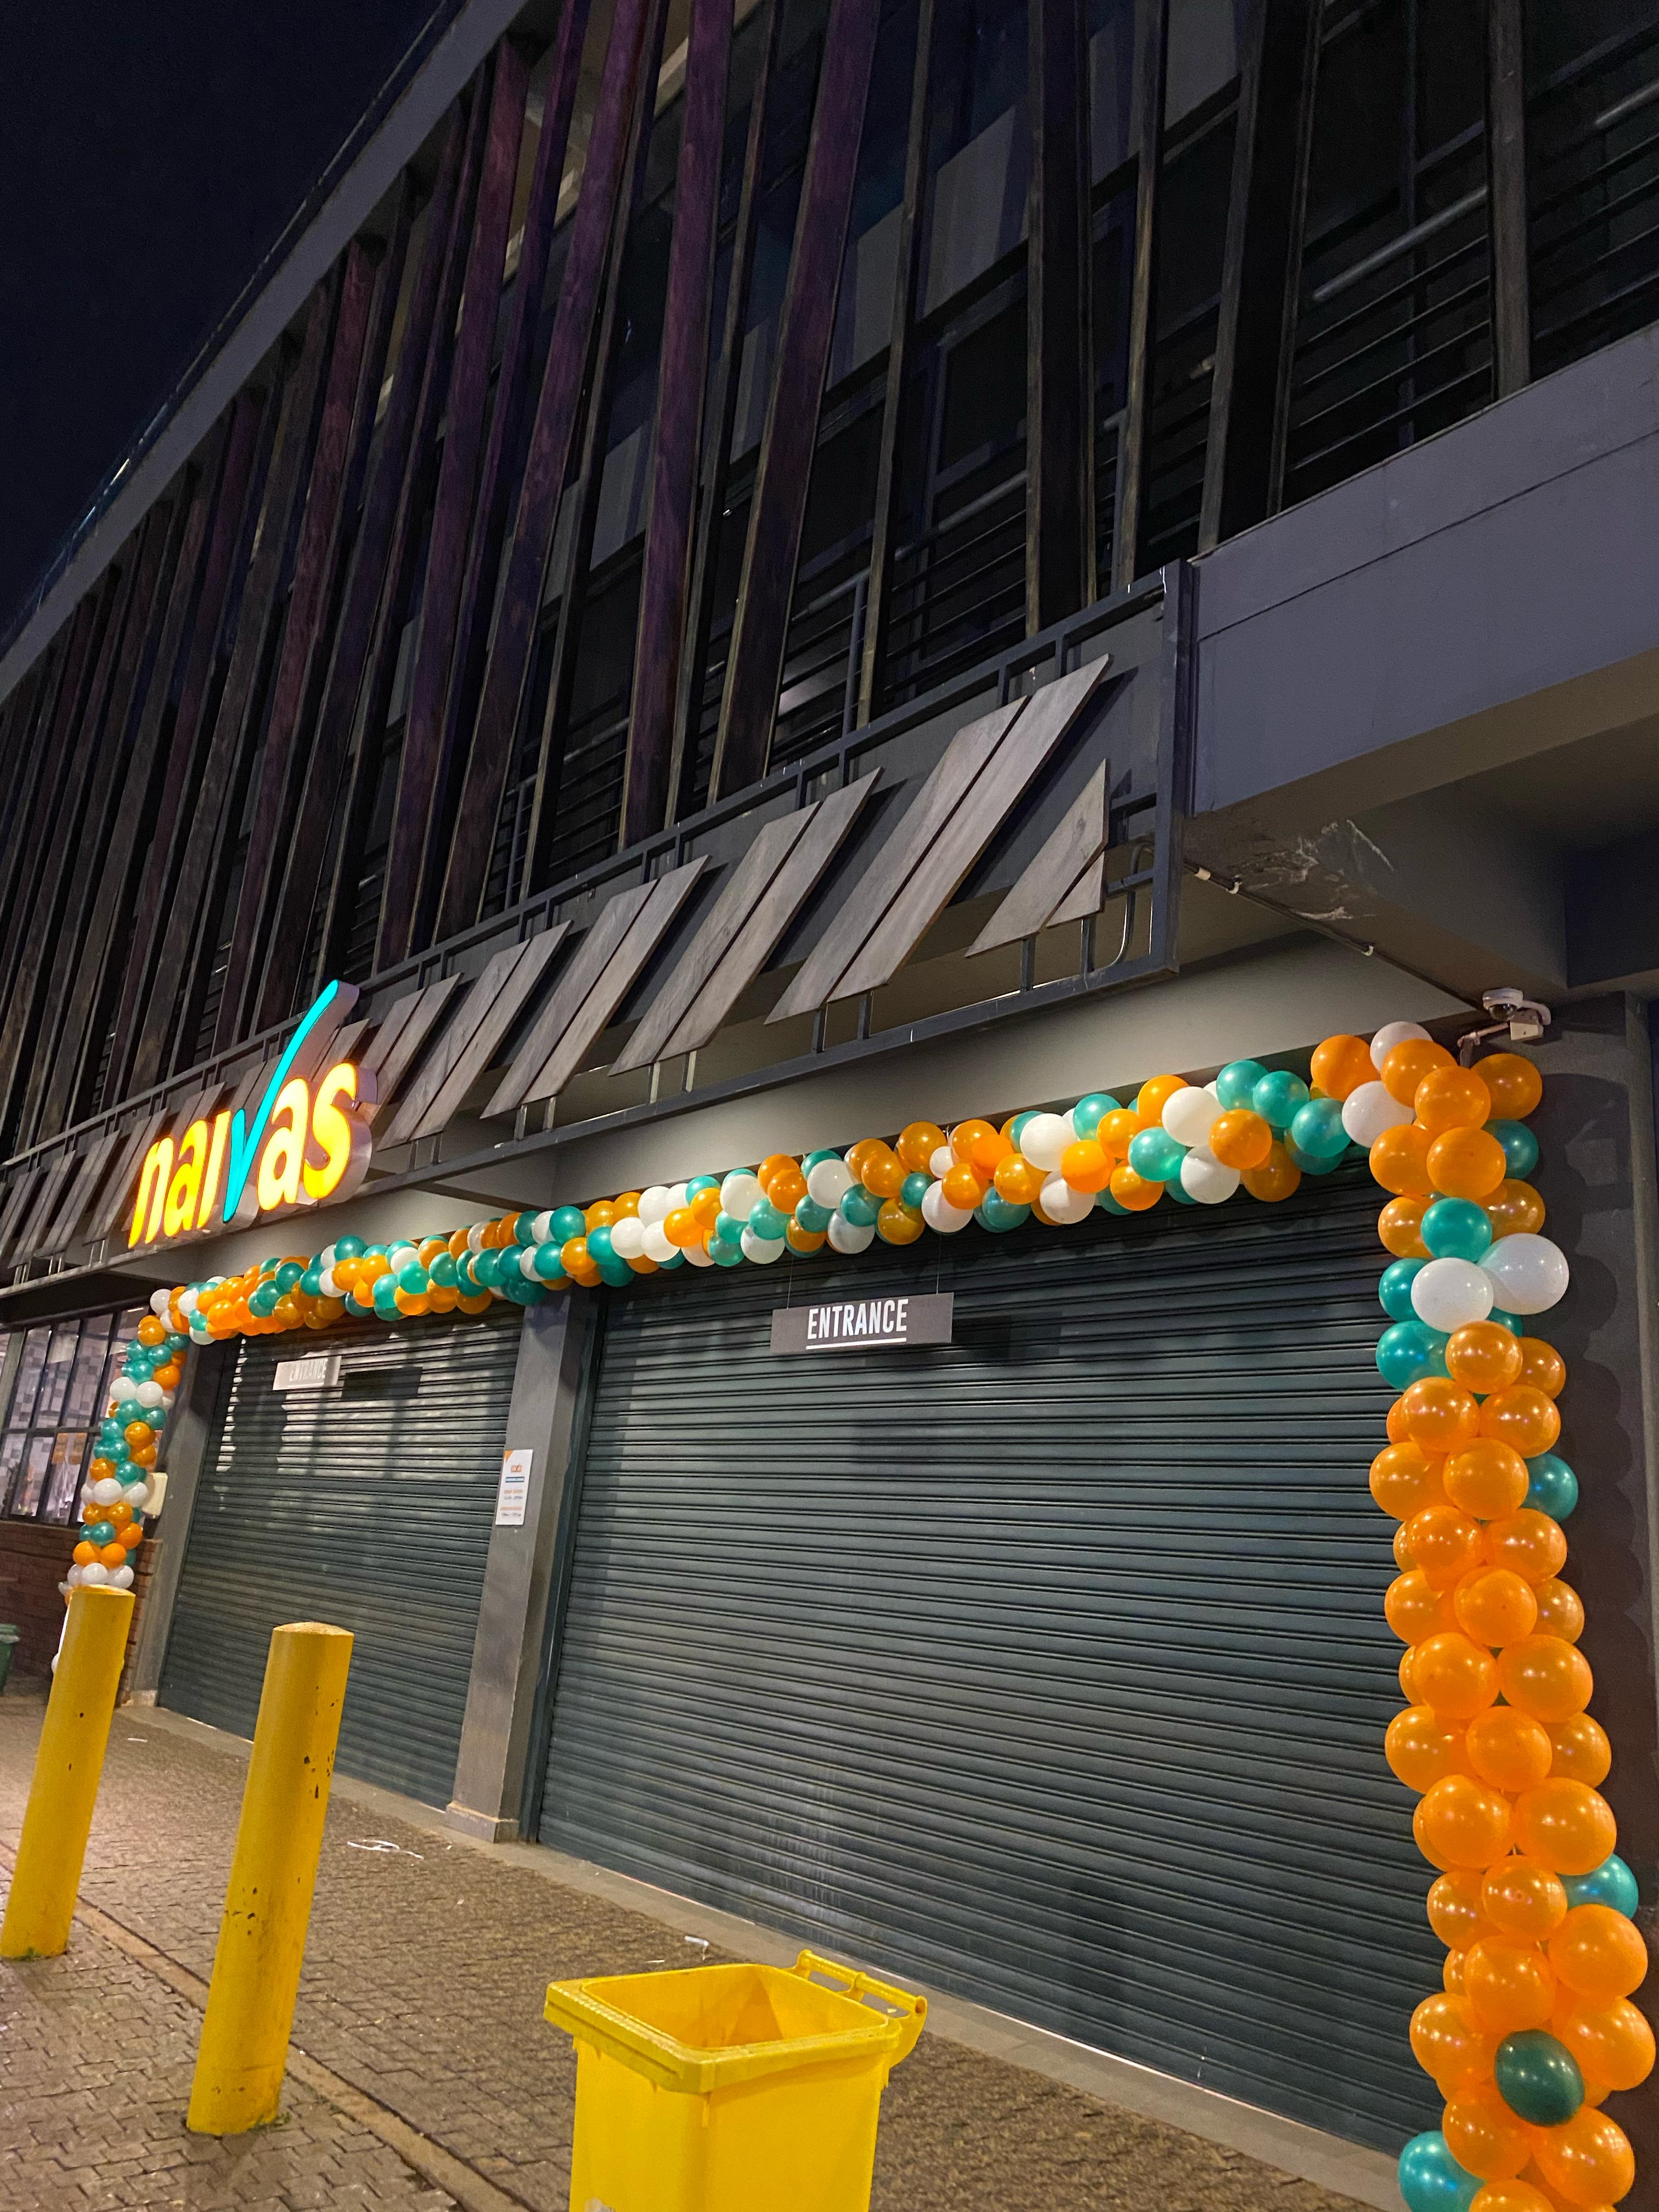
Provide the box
[546,1951,927,2212]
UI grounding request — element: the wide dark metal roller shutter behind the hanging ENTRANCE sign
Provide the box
[540,1175,1440,2146]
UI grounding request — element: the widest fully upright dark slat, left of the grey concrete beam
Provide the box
[1026,0,1095,630]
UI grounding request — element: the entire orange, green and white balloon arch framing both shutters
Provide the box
[69,1022,1655,2212]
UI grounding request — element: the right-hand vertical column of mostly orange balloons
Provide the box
[1314,1022,1655,2212]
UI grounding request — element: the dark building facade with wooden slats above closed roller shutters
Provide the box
[0,0,1659,2203]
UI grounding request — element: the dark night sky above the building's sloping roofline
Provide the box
[0,0,449,626]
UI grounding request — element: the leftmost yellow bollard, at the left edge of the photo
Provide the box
[0,1586,133,1957]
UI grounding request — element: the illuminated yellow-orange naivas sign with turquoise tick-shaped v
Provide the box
[128,982,374,1245]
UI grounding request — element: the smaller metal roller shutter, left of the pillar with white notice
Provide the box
[159,1312,517,1805]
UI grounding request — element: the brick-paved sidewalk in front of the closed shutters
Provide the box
[0,1697,1358,2212]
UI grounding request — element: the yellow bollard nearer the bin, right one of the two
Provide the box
[186,1621,352,2135]
